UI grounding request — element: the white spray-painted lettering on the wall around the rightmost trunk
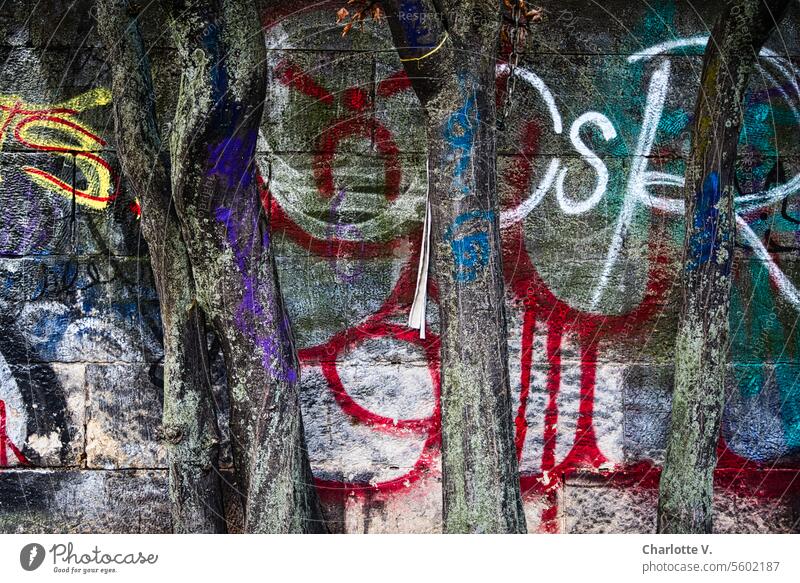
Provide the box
[498,35,800,310]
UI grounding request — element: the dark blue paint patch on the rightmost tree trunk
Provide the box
[687,172,731,273]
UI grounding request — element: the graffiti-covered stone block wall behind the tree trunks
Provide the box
[0,0,800,532]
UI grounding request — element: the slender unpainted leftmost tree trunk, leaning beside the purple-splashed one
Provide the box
[97,0,225,533]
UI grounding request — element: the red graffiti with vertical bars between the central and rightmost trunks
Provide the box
[503,122,668,532]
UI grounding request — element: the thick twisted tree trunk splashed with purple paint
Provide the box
[170,0,324,533]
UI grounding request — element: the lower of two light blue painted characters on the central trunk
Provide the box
[445,211,494,283]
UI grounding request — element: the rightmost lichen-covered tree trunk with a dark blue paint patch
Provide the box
[658,0,789,533]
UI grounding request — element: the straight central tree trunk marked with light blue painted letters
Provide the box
[383,0,526,532]
